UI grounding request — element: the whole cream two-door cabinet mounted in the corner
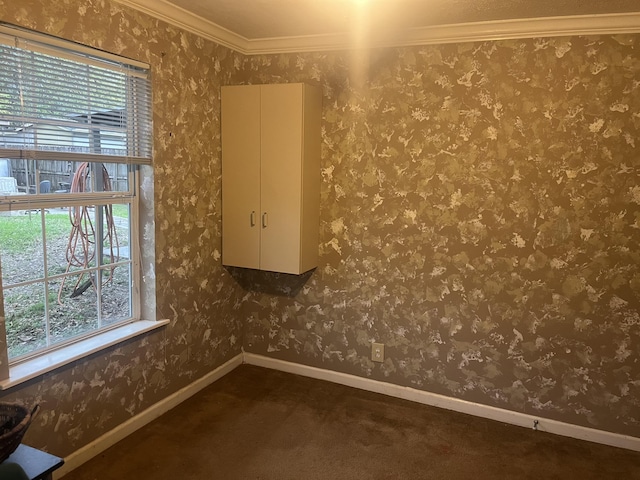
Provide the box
[222,83,322,274]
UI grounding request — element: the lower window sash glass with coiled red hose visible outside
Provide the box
[0,188,135,358]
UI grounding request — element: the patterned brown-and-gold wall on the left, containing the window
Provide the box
[0,0,242,455]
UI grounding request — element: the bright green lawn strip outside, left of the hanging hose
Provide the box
[0,214,71,253]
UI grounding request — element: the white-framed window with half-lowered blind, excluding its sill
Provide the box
[0,25,152,363]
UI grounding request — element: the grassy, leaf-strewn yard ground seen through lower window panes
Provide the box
[0,205,129,358]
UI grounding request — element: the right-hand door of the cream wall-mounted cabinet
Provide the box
[260,84,303,274]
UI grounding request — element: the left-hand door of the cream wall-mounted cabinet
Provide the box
[221,85,261,268]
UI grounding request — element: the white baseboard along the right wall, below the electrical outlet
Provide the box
[244,352,640,451]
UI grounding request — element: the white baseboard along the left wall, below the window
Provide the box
[53,354,243,480]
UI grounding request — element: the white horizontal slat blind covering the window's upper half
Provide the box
[0,25,152,164]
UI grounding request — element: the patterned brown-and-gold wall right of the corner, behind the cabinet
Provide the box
[242,36,640,437]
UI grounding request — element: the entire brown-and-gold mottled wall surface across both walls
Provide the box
[0,0,640,455]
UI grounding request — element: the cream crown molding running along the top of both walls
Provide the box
[115,0,640,55]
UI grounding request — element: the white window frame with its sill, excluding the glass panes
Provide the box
[0,22,164,390]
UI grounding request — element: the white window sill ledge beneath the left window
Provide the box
[0,320,169,390]
